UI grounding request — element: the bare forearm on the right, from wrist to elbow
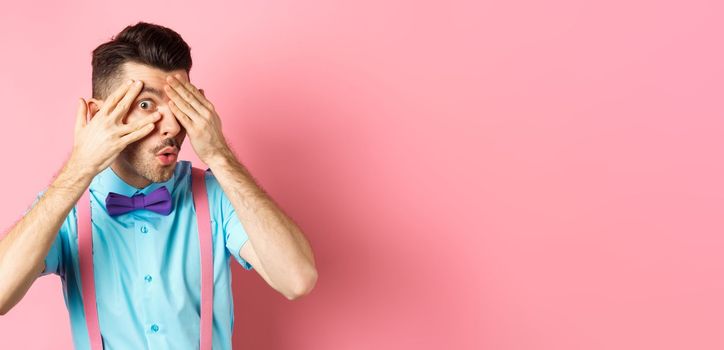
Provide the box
[209,151,316,292]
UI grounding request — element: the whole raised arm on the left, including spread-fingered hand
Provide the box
[0,81,161,315]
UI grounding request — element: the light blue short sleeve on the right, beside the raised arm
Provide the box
[206,170,253,270]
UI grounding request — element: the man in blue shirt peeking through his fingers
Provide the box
[0,22,317,349]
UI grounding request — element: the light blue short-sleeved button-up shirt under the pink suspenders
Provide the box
[33,160,252,350]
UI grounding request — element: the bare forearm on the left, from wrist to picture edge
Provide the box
[0,157,93,314]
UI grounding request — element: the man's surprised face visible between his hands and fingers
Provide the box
[90,62,188,188]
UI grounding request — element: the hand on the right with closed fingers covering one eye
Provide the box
[164,74,231,164]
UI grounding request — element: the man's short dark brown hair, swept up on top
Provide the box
[91,22,191,99]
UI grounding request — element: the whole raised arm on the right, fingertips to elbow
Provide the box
[164,74,317,300]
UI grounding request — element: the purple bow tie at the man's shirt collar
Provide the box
[106,186,172,216]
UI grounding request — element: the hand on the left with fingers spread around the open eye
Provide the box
[69,80,161,176]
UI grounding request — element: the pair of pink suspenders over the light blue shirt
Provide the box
[77,167,214,350]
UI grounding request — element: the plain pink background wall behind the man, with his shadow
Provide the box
[0,0,724,350]
